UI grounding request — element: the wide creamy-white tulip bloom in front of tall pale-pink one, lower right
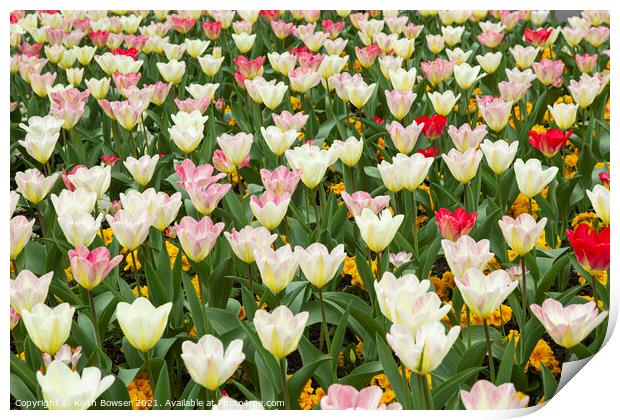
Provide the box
[387,322,461,375]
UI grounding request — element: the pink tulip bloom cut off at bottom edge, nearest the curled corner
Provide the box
[461,379,530,410]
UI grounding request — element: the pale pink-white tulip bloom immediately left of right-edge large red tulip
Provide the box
[497,213,547,256]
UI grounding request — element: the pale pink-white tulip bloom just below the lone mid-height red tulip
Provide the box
[441,235,493,278]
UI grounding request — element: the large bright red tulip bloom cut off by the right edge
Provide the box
[566,223,609,274]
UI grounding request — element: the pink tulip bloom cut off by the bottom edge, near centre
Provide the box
[321,384,402,410]
